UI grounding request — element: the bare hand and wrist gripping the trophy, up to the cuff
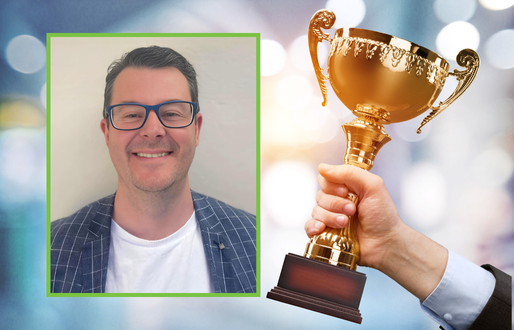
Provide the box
[305,164,448,301]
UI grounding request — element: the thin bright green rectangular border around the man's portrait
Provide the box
[46,33,261,297]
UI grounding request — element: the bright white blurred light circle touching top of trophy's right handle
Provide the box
[435,21,480,60]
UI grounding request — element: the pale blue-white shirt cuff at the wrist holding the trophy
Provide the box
[421,250,496,330]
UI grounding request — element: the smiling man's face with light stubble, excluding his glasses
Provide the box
[100,67,202,192]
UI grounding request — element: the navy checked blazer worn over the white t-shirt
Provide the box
[50,191,257,293]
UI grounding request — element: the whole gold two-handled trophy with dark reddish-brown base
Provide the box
[267,10,480,323]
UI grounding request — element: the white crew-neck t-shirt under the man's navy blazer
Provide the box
[105,212,214,293]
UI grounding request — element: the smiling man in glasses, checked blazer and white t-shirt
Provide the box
[51,46,256,293]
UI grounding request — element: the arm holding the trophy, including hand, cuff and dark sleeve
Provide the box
[305,164,512,330]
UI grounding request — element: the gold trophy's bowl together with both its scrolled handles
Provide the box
[308,10,480,133]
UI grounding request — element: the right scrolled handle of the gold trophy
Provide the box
[416,48,480,134]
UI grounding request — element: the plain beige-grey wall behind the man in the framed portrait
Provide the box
[48,37,256,221]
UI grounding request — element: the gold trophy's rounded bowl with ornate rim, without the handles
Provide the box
[325,28,449,124]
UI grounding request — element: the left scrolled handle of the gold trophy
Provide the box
[307,9,336,106]
